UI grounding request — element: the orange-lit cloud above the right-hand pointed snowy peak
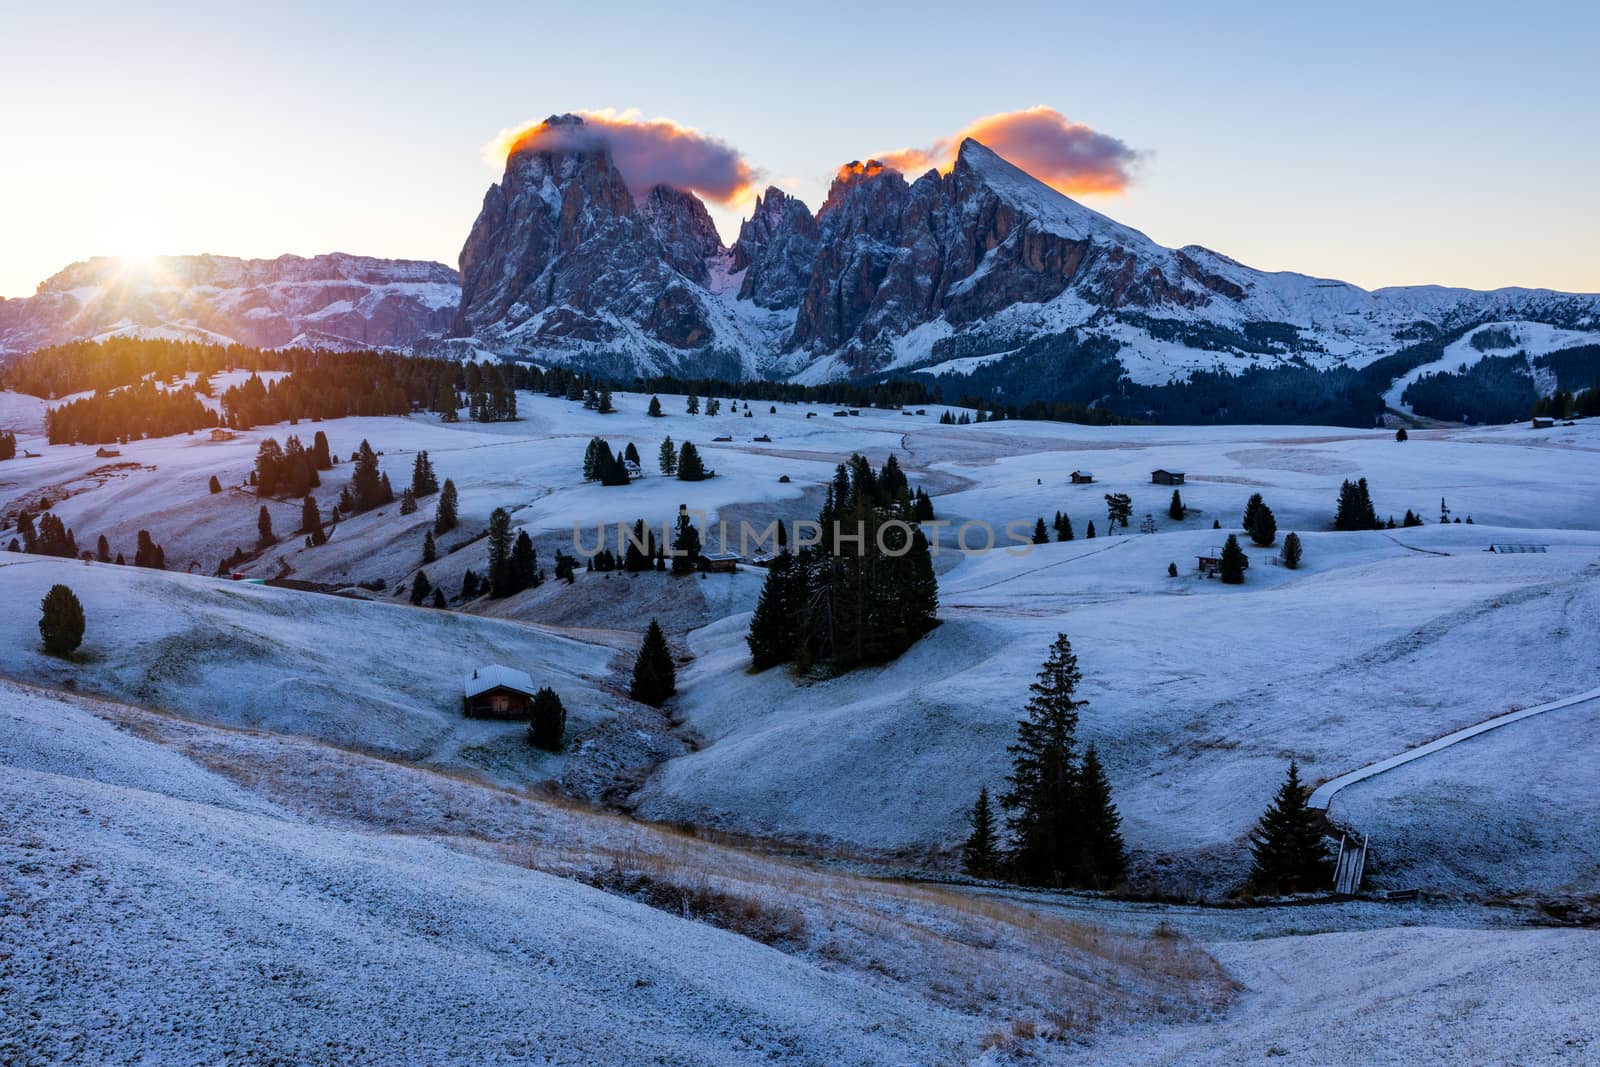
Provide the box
[874,104,1139,195]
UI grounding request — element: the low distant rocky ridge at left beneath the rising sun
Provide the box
[0,253,461,355]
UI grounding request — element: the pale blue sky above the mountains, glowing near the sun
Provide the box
[0,0,1600,296]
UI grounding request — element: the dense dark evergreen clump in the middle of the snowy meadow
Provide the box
[746,454,939,673]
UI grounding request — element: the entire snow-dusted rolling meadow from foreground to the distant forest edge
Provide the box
[0,394,1600,1064]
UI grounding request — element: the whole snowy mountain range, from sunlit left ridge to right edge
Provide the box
[0,115,1600,415]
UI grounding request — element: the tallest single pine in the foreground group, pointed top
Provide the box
[1000,633,1083,885]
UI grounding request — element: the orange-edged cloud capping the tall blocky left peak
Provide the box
[483,109,758,205]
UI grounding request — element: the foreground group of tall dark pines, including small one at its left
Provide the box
[962,633,1128,889]
